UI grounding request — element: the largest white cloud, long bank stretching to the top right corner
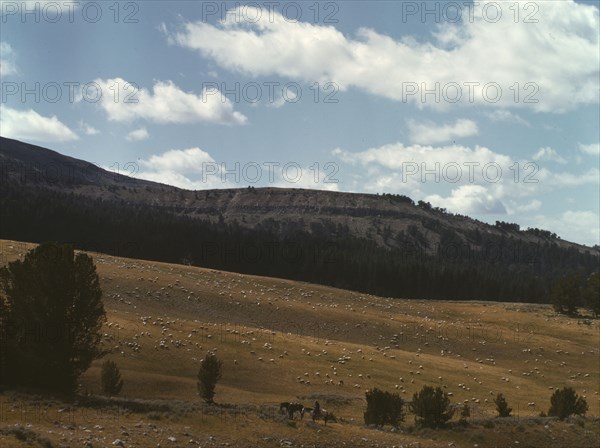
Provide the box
[168,0,600,112]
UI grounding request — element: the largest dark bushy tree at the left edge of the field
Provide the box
[0,243,105,393]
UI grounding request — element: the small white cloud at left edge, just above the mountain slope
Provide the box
[0,106,79,142]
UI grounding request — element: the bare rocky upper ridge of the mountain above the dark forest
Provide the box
[0,137,598,253]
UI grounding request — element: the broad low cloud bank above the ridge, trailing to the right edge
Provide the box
[333,138,600,219]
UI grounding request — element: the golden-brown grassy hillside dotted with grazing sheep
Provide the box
[0,240,600,448]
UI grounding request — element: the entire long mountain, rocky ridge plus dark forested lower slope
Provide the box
[0,139,600,303]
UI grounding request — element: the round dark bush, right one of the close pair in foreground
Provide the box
[410,386,454,428]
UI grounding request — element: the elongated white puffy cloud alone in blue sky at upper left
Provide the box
[95,78,247,124]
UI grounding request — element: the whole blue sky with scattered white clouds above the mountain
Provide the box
[0,0,600,244]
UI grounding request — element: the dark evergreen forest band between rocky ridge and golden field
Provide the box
[0,183,599,303]
